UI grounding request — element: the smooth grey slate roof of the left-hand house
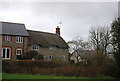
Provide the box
[0,22,29,36]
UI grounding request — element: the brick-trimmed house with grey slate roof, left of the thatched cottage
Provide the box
[0,22,29,60]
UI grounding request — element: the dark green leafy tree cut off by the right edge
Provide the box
[111,18,120,68]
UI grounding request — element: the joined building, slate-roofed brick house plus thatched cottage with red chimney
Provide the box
[0,22,69,61]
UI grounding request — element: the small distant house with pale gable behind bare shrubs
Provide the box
[70,50,96,63]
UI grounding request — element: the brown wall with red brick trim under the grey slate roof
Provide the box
[2,36,28,60]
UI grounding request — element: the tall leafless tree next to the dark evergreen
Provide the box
[89,26,111,54]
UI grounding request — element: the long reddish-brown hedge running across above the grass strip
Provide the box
[2,60,118,77]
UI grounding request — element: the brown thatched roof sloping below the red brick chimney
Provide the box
[28,30,68,48]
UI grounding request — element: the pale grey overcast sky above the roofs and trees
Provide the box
[0,2,118,41]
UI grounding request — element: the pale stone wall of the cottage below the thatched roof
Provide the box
[29,46,69,62]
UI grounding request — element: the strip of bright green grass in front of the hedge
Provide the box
[2,73,116,81]
